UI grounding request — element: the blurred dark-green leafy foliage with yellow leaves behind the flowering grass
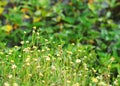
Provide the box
[0,0,120,58]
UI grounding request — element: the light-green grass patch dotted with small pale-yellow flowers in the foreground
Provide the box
[0,30,120,86]
